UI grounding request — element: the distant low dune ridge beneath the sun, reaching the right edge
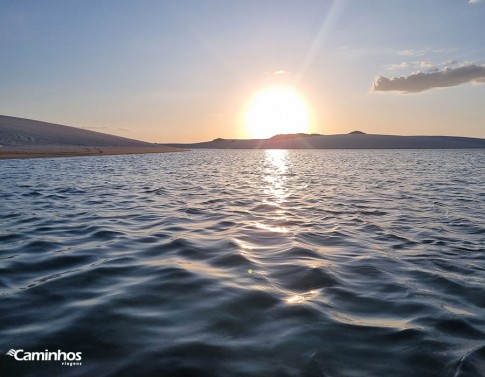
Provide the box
[165,131,485,149]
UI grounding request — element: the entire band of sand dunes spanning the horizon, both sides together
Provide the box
[0,115,485,158]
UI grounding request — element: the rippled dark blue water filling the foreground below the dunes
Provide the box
[0,150,485,377]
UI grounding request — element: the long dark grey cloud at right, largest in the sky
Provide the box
[372,64,485,93]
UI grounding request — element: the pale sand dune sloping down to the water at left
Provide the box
[0,115,180,158]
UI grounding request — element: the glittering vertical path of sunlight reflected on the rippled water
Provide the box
[237,150,321,305]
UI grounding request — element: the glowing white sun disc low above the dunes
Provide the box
[245,87,309,139]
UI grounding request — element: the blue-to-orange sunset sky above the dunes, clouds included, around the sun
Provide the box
[0,0,485,143]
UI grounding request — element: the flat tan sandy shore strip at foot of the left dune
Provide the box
[0,146,187,160]
